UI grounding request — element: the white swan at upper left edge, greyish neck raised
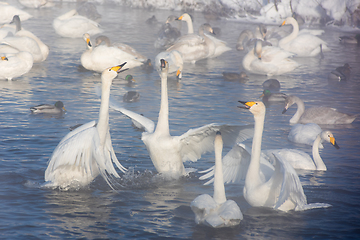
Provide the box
[0,15,50,63]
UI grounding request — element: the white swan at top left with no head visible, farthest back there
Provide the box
[53,9,103,38]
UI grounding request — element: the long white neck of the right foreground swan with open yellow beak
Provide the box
[245,111,265,188]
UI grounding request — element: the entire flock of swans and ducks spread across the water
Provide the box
[0,2,357,227]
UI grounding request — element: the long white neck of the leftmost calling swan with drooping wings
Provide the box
[96,80,111,146]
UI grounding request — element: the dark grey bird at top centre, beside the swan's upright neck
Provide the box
[154,15,181,49]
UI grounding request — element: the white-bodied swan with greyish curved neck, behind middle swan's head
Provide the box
[166,23,216,64]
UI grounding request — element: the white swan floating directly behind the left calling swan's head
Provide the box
[81,33,147,72]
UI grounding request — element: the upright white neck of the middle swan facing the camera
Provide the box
[155,72,170,134]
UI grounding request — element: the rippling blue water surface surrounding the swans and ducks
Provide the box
[0,3,360,239]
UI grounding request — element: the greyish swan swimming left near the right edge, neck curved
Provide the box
[283,95,357,124]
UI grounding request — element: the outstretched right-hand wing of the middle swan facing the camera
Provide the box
[179,123,254,161]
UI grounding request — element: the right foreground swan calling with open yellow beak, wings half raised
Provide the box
[241,101,330,211]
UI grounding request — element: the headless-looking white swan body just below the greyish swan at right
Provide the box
[288,123,323,148]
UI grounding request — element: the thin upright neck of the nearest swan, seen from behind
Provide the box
[214,140,226,204]
